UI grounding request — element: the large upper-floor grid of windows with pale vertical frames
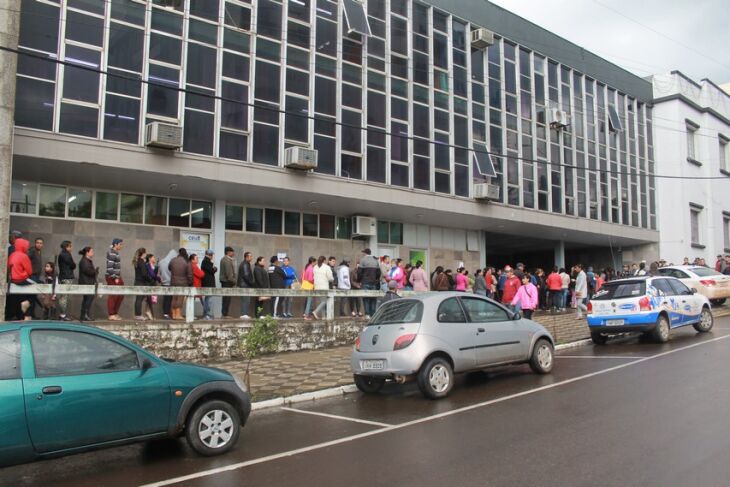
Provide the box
[16,0,656,229]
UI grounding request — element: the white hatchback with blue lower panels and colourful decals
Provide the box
[588,276,713,345]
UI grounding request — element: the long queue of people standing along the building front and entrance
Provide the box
[5,231,730,321]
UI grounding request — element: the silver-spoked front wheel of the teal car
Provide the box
[185,400,241,457]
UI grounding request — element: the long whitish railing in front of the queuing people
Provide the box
[8,284,415,323]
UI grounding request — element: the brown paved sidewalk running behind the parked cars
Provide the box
[209,305,730,401]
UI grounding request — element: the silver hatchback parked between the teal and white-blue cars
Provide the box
[351,292,555,399]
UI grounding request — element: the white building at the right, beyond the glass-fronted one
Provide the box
[652,71,730,265]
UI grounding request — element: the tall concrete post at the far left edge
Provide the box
[0,0,20,313]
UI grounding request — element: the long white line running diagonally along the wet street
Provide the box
[143,335,730,487]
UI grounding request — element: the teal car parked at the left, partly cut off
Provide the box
[0,322,251,467]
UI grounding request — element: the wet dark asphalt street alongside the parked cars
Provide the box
[5,317,730,487]
